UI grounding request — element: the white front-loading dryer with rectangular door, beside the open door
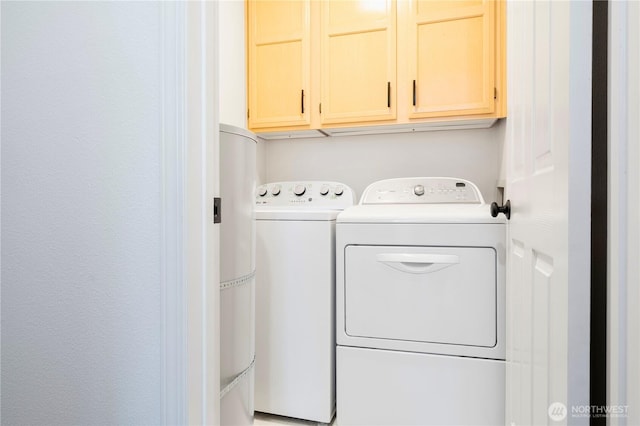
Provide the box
[336,178,506,426]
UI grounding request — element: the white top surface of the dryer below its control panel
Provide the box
[337,204,505,224]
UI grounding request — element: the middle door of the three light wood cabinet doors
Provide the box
[321,0,396,124]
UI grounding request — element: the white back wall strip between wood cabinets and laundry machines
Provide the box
[264,122,504,203]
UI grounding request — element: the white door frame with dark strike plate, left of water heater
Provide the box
[160,1,220,425]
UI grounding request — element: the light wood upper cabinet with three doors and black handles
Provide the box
[247,0,506,133]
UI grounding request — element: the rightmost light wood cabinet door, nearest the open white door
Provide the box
[407,0,496,118]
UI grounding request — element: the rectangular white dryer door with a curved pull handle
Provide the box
[345,245,497,347]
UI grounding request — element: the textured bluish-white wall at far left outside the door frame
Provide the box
[1,1,162,425]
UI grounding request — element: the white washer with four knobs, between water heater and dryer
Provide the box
[255,181,354,423]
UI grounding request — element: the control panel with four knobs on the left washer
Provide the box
[256,181,355,209]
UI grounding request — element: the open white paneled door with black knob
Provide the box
[505,0,592,425]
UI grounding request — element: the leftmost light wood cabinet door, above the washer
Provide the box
[247,0,311,129]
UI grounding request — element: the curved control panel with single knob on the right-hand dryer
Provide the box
[360,177,484,204]
